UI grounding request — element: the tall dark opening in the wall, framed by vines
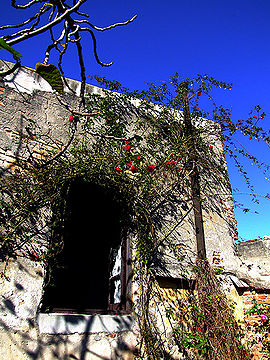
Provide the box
[43,181,127,313]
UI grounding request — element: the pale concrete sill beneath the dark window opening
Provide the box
[37,313,135,334]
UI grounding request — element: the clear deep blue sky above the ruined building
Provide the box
[0,0,270,239]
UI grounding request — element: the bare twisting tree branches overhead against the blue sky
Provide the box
[0,0,137,97]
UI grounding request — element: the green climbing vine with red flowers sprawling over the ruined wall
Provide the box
[0,74,269,360]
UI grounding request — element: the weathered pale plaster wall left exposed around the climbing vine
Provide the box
[0,59,270,360]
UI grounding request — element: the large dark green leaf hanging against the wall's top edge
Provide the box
[36,62,64,94]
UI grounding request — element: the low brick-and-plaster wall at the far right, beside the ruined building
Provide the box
[234,236,270,360]
